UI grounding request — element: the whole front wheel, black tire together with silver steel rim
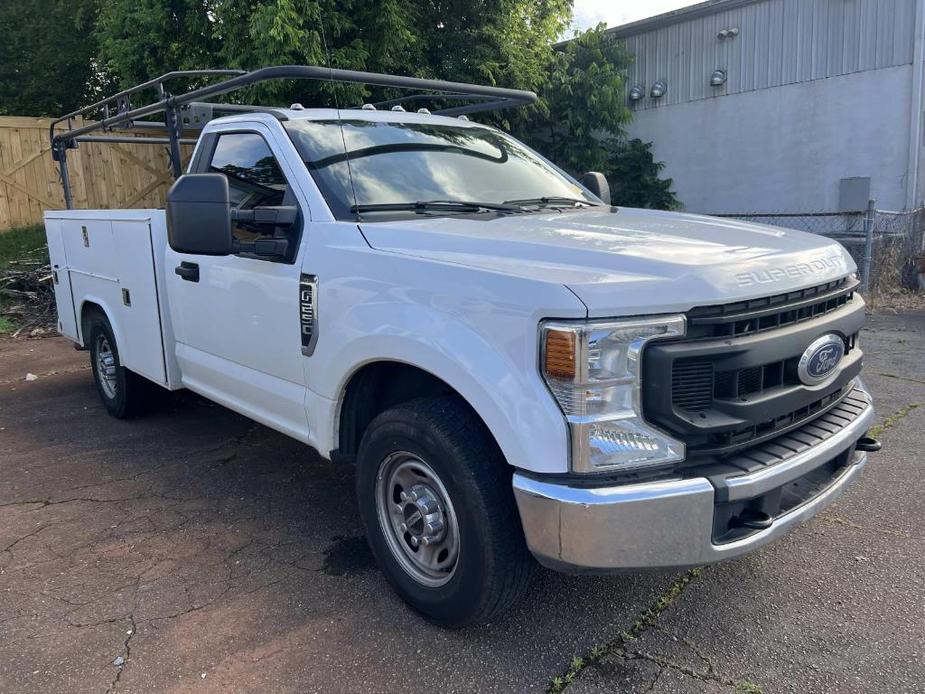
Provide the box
[357,397,534,627]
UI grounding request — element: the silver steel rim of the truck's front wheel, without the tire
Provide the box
[376,451,459,587]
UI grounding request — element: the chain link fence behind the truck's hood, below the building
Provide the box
[719,208,925,296]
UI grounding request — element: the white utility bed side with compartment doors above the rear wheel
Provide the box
[45,210,179,388]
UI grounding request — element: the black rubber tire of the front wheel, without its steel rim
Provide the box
[357,396,535,628]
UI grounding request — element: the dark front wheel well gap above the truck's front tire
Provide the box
[331,362,465,461]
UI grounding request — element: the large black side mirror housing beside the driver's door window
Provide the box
[167,174,233,255]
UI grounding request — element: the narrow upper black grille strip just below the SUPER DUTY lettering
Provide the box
[687,277,858,340]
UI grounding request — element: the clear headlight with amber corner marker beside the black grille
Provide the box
[540,316,685,472]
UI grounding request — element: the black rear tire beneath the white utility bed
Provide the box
[84,311,158,419]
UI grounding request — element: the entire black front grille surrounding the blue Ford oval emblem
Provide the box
[642,278,864,459]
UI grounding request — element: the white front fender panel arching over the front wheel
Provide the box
[304,231,585,473]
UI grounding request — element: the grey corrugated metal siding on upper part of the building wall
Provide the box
[624,0,915,108]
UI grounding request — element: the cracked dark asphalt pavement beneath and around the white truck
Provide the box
[0,314,925,694]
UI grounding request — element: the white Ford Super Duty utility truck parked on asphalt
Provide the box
[45,68,879,626]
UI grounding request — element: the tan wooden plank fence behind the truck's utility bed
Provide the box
[0,117,192,233]
